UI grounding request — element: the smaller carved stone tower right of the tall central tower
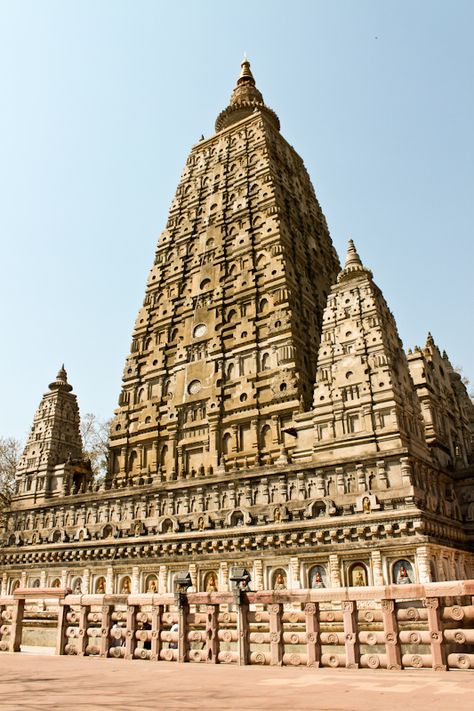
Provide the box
[314,240,429,459]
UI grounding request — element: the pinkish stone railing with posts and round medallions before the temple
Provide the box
[0,580,474,670]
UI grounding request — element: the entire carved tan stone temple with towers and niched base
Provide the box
[0,61,474,593]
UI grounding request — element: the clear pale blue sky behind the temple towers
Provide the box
[0,0,474,438]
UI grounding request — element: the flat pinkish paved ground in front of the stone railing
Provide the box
[0,654,474,711]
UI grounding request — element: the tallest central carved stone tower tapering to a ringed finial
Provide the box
[110,60,339,481]
